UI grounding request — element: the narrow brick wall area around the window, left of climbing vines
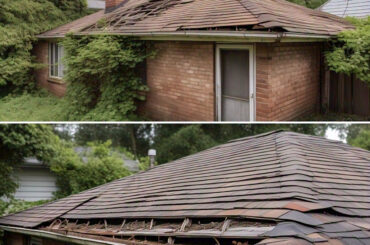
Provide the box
[33,41,66,97]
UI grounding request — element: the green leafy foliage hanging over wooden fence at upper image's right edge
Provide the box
[325,17,370,86]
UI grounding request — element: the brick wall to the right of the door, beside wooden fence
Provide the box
[256,43,321,121]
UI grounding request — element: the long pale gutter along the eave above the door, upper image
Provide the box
[37,31,331,42]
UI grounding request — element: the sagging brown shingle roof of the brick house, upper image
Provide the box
[40,0,352,38]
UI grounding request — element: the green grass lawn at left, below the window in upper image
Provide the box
[0,92,65,121]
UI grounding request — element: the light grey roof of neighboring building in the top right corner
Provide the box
[318,0,370,18]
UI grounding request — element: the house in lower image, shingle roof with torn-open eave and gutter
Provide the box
[0,131,370,245]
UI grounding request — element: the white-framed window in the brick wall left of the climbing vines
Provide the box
[49,43,65,78]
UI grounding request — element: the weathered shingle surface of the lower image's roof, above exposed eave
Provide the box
[0,131,370,245]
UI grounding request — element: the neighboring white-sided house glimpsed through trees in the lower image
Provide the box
[14,147,139,201]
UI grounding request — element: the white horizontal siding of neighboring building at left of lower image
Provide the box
[14,167,57,201]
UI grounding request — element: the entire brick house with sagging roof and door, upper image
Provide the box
[35,0,352,121]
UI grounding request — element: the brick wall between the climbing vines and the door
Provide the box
[140,42,215,121]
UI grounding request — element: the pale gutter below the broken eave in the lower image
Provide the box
[0,225,125,245]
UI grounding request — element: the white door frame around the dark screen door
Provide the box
[216,44,256,121]
